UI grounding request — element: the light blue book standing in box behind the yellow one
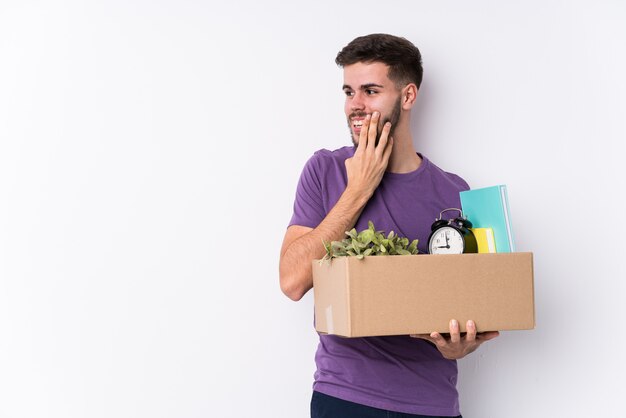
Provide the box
[459,185,515,253]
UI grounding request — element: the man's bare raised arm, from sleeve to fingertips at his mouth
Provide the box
[279,112,393,301]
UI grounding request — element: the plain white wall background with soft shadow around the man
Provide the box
[0,0,626,418]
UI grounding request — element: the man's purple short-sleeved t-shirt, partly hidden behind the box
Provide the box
[289,146,469,416]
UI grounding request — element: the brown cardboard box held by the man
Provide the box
[313,253,535,337]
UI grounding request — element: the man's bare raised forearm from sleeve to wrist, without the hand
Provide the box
[280,190,368,300]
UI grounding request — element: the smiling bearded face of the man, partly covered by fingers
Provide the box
[343,62,401,146]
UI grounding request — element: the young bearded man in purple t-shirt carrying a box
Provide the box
[280,34,498,418]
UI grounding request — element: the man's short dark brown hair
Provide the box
[335,33,424,89]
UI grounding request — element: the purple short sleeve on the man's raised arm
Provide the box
[289,153,326,228]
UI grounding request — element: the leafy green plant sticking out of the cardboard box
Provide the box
[322,221,418,260]
